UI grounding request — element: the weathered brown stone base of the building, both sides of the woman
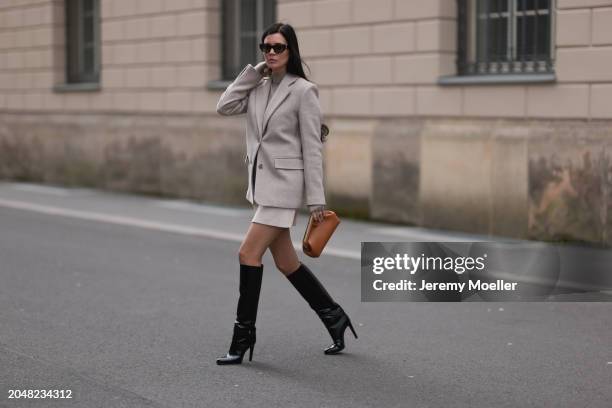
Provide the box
[0,114,612,245]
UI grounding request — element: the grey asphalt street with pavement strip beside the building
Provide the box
[0,183,612,408]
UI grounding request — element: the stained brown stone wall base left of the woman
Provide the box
[0,114,246,205]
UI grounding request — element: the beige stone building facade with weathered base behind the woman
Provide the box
[0,0,612,245]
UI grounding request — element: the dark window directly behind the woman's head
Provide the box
[221,0,276,80]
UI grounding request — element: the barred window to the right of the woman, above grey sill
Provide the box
[457,0,554,75]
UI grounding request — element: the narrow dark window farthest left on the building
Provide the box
[65,0,100,83]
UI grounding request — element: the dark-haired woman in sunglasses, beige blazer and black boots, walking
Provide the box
[217,23,357,364]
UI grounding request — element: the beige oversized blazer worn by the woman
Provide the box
[217,64,325,208]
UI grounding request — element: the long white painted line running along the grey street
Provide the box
[0,198,361,259]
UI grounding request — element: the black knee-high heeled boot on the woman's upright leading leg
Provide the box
[217,264,263,365]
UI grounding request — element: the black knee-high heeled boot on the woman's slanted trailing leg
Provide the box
[287,263,357,354]
